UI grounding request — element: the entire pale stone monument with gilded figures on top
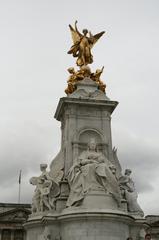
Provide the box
[25,21,145,240]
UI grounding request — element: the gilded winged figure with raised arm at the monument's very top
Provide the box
[68,21,105,67]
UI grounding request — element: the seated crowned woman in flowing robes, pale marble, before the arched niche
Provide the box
[67,139,120,206]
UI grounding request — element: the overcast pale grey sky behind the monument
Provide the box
[0,0,159,214]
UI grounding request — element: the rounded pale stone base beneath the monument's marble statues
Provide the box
[25,207,144,240]
